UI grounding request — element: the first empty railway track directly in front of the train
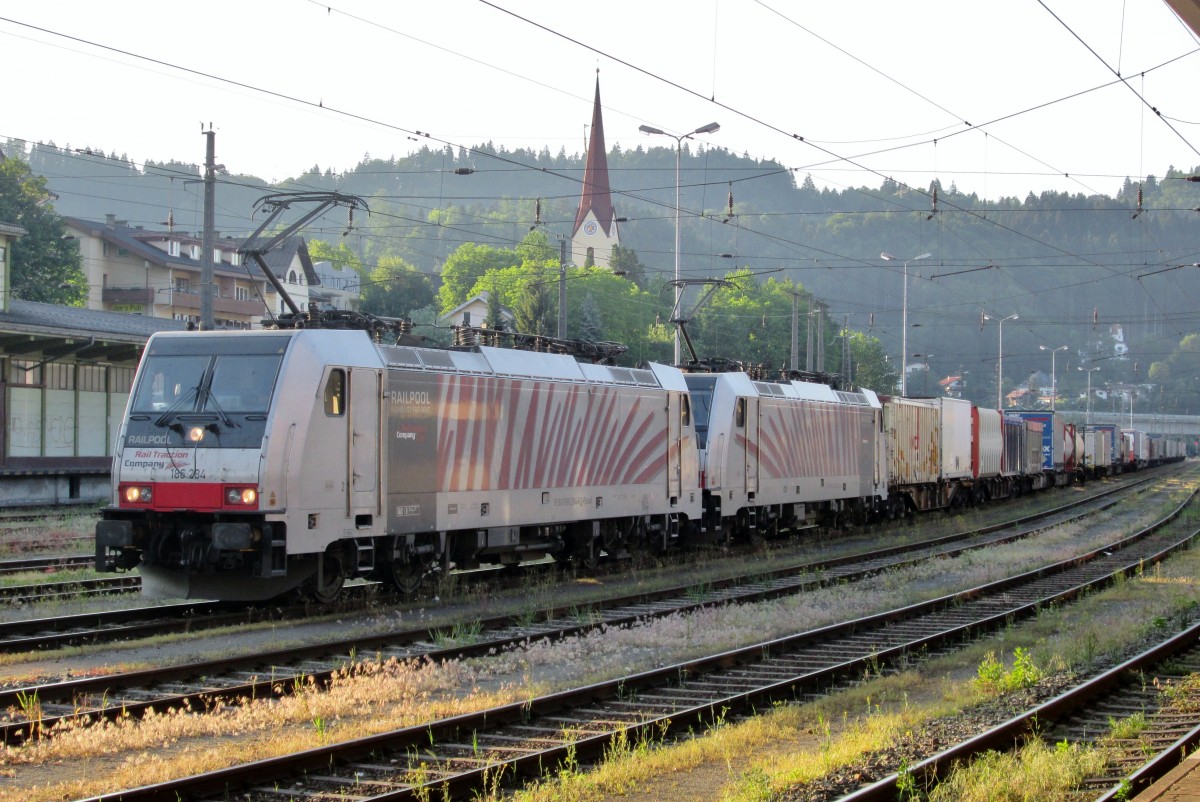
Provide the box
[0,465,1180,743]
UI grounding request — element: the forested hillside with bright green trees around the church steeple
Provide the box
[7,140,1200,414]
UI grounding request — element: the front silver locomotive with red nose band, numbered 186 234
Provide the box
[103,329,701,599]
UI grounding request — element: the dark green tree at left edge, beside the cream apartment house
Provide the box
[0,158,88,306]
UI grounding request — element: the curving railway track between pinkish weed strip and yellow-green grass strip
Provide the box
[63,463,1196,802]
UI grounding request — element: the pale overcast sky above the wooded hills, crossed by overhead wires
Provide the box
[0,0,1200,198]
